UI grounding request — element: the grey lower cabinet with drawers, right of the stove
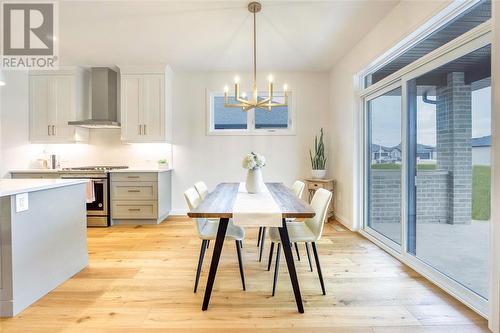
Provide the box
[111,171,171,225]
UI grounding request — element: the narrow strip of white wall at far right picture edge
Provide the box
[489,1,500,333]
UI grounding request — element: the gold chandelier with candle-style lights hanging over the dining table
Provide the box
[224,2,288,111]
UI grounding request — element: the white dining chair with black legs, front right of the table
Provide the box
[267,189,332,296]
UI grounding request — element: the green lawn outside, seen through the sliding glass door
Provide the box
[372,163,491,221]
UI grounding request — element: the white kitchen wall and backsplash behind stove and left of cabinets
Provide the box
[0,71,172,178]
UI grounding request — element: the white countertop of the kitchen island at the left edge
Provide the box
[0,179,88,197]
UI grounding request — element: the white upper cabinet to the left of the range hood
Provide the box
[29,68,90,143]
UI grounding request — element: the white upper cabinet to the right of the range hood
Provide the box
[121,67,172,142]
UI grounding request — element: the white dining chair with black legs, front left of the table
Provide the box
[184,187,246,292]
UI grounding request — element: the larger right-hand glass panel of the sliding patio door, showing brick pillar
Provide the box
[407,45,491,298]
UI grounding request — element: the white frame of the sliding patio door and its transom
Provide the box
[354,0,493,319]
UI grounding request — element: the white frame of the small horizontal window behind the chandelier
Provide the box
[206,91,296,136]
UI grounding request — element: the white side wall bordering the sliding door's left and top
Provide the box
[329,1,448,230]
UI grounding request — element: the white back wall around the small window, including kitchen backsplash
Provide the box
[0,72,329,213]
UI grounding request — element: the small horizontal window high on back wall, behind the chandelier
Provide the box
[207,92,294,135]
